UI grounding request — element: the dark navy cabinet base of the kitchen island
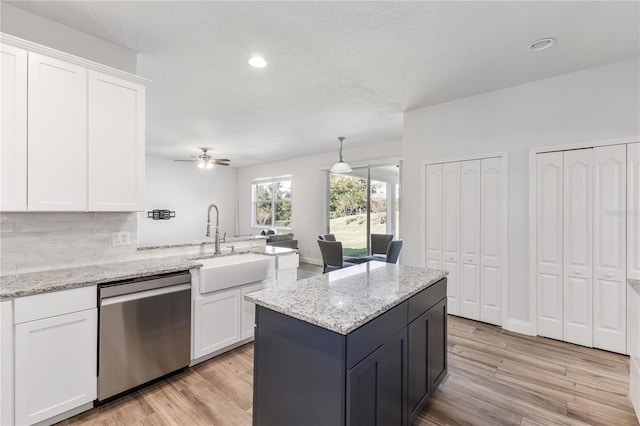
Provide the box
[253,278,447,426]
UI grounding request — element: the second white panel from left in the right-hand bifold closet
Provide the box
[563,149,593,346]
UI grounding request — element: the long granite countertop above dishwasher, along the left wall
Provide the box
[0,247,296,300]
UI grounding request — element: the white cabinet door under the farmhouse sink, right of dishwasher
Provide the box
[194,289,242,358]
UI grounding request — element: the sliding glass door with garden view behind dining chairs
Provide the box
[328,164,400,256]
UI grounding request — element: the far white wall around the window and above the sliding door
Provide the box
[237,141,402,264]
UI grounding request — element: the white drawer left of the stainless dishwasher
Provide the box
[14,286,97,324]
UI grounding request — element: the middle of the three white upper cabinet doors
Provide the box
[28,52,87,211]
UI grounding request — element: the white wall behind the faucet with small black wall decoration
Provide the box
[138,156,236,245]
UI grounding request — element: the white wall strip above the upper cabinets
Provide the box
[0,2,137,74]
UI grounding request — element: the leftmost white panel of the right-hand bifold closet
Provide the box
[536,152,564,339]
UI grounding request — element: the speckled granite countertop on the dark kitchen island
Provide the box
[245,262,447,335]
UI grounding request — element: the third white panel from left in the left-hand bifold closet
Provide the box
[460,160,481,320]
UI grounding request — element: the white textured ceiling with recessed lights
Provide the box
[8,1,640,166]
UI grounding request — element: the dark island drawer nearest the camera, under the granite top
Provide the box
[347,301,407,368]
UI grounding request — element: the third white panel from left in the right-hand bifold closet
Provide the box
[593,145,627,353]
